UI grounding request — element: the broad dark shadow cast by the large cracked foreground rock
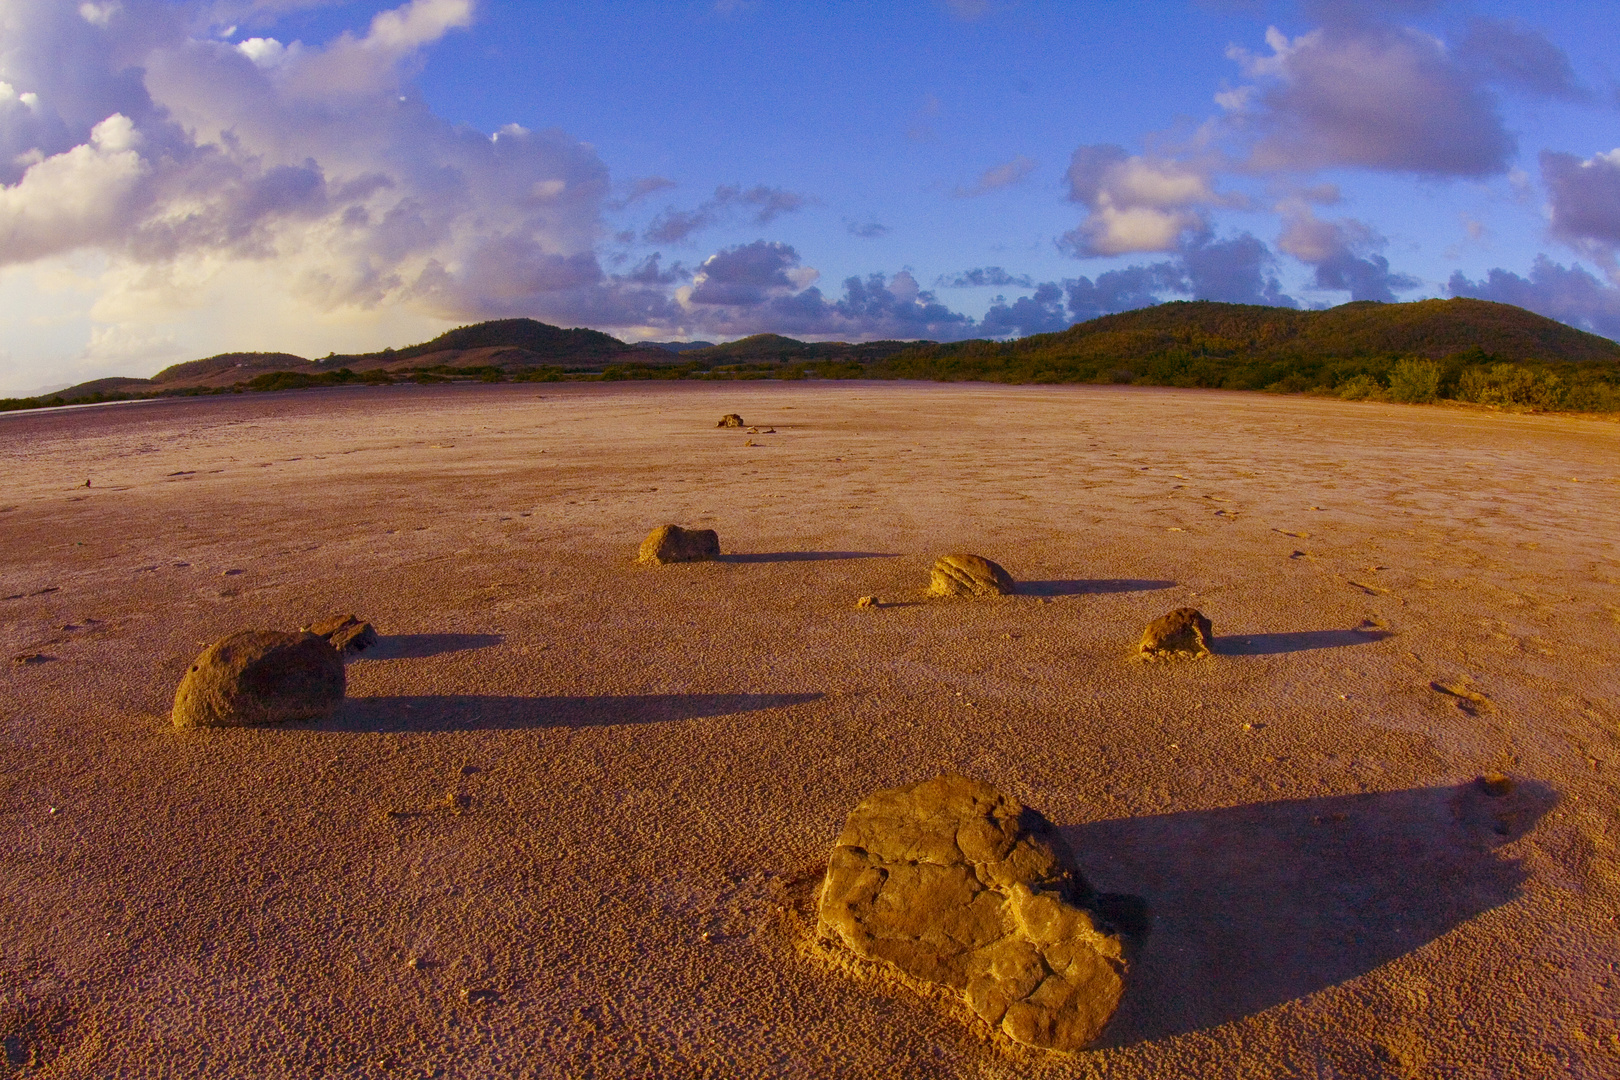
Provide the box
[1063,782,1557,1046]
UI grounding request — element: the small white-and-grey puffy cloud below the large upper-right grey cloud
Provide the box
[1061,144,1238,256]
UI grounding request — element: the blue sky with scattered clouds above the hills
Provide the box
[0,0,1620,397]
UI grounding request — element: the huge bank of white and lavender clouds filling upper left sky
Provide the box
[0,0,722,351]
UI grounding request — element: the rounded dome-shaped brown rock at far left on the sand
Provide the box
[173,630,345,727]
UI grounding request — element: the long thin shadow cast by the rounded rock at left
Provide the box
[313,693,821,732]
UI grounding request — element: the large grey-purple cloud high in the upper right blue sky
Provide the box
[1221,23,1515,176]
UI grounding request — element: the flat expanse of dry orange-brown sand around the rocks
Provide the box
[0,384,1620,1077]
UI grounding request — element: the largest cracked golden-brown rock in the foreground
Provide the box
[818,776,1126,1051]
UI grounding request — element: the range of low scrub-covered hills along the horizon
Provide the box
[12,298,1620,408]
